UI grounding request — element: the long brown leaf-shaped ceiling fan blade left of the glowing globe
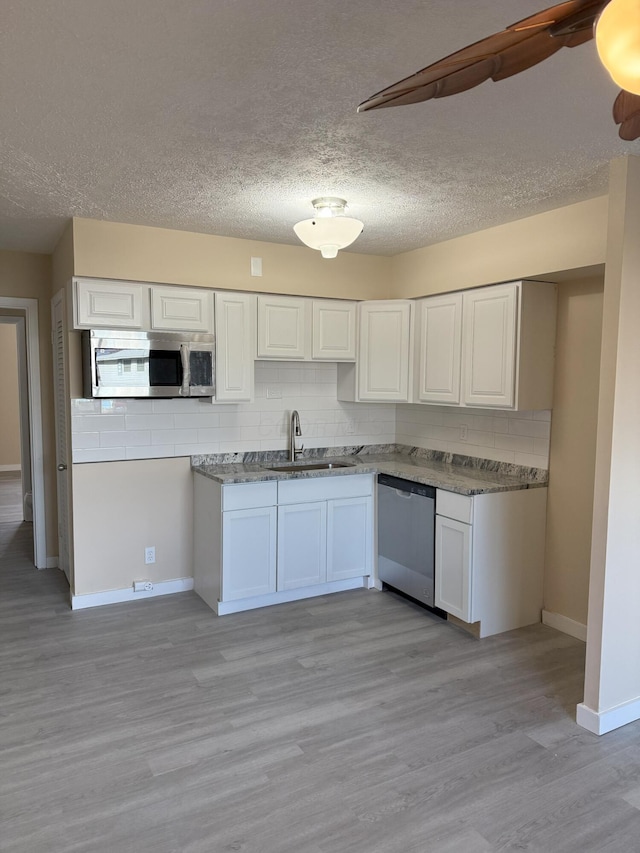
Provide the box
[358,0,608,112]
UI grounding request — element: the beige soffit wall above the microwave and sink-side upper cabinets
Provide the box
[73,219,391,299]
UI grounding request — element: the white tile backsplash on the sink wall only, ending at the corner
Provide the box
[71,361,396,462]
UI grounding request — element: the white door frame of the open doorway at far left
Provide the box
[0,296,47,569]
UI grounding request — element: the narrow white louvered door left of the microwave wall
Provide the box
[51,291,73,590]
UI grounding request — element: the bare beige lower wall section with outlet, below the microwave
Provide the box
[73,457,193,595]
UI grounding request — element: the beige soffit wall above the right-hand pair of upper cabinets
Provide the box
[392,196,608,298]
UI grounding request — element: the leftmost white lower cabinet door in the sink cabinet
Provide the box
[220,506,276,601]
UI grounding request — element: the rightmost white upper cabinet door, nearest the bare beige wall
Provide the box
[462,284,518,408]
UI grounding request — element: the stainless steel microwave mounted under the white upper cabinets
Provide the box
[82,329,215,398]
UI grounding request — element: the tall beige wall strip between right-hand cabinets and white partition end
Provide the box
[544,277,604,625]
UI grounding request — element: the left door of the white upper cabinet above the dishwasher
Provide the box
[418,293,462,405]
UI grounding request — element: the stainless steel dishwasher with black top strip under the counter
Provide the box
[378,474,445,616]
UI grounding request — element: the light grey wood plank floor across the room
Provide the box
[0,492,640,853]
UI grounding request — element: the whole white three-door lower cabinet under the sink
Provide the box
[194,474,374,615]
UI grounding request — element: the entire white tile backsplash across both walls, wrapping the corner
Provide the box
[71,361,551,468]
